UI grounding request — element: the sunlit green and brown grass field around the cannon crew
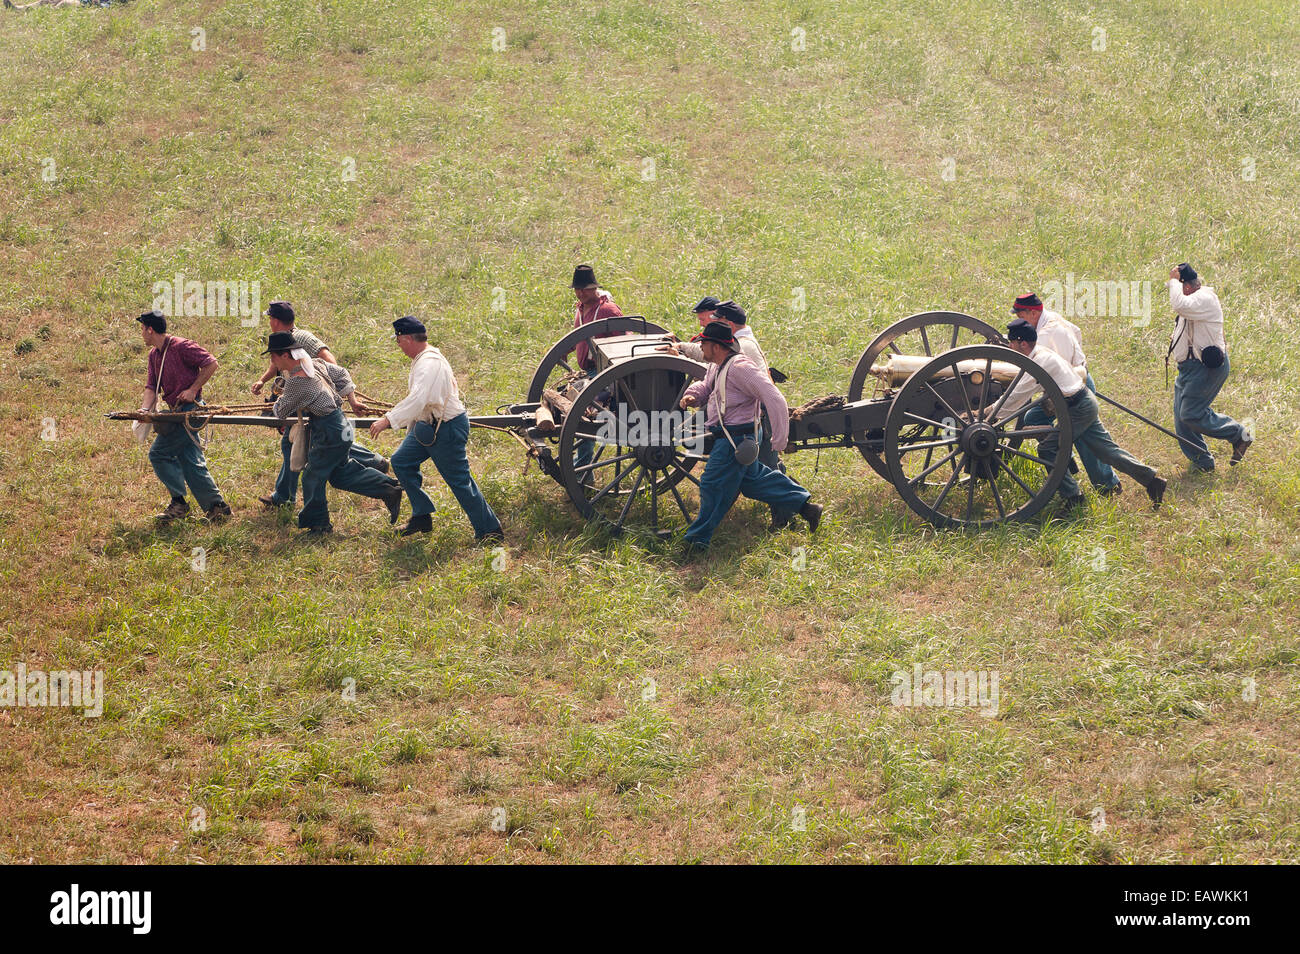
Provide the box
[0,0,1300,863]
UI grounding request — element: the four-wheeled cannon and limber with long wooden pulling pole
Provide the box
[109,312,1073,537]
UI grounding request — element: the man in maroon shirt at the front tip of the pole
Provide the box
[137,311,230,522]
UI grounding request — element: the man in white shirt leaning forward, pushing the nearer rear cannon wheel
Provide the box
[998,318,1165,509]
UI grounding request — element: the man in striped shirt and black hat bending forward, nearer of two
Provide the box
[263,331,402,533]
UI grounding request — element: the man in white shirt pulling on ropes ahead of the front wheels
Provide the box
[371,316,506,543]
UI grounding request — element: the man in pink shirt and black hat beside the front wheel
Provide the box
[681,321,822,551]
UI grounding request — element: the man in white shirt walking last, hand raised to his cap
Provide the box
[1169,263,1252,471]
